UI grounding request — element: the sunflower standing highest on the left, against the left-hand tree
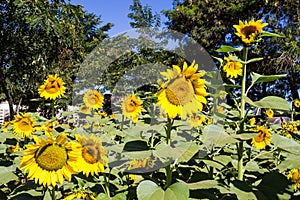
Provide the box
[39,74,66,100]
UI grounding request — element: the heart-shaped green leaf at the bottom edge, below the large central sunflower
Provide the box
[137,180,189,200]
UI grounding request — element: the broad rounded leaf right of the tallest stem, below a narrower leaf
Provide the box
[245,96,290,111]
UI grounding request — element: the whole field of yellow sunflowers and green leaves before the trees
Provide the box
[0,19,300,200]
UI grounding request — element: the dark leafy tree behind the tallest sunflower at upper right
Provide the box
[163,0,300,103]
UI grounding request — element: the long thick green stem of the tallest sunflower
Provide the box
[237,47,248,181]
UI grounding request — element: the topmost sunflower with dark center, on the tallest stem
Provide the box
[233,19,268,45]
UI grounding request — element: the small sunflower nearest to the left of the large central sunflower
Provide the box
[122,94,143,123]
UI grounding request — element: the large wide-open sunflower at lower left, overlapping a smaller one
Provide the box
[21,133,81,187]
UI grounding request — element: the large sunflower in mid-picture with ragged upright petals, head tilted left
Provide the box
[156,63,207,119]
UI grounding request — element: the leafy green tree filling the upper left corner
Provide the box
[0,0,112,118]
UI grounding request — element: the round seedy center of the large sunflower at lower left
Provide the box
[35,144,68,171]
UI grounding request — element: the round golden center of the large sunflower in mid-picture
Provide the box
[166,78,194,106]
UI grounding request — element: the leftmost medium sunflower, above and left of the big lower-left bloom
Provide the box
[13,113,35,137]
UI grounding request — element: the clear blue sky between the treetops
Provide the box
[71,0,173,36]
